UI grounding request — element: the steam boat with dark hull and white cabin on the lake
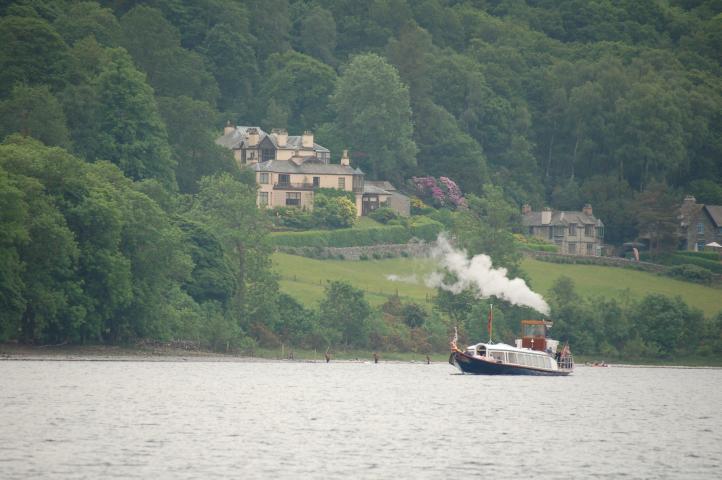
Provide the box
[449,320,574,376]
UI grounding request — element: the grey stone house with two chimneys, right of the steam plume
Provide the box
[521,203,604,256]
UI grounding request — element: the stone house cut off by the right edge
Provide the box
[679,195,722,252]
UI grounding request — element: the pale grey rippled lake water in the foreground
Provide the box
[0,361,722,480]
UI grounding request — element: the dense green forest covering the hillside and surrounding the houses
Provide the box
[0,0,722,355]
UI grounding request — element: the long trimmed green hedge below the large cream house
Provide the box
[271,218,443,247]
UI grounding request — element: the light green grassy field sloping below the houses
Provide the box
[273,253,722,316]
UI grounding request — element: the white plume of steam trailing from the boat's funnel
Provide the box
[426,235,549,315]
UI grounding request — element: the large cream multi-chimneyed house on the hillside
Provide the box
[216,122,404,216]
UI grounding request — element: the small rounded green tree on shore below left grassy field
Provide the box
[319,281,371,345]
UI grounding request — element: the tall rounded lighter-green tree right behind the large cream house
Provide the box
[332,54,417,181]
